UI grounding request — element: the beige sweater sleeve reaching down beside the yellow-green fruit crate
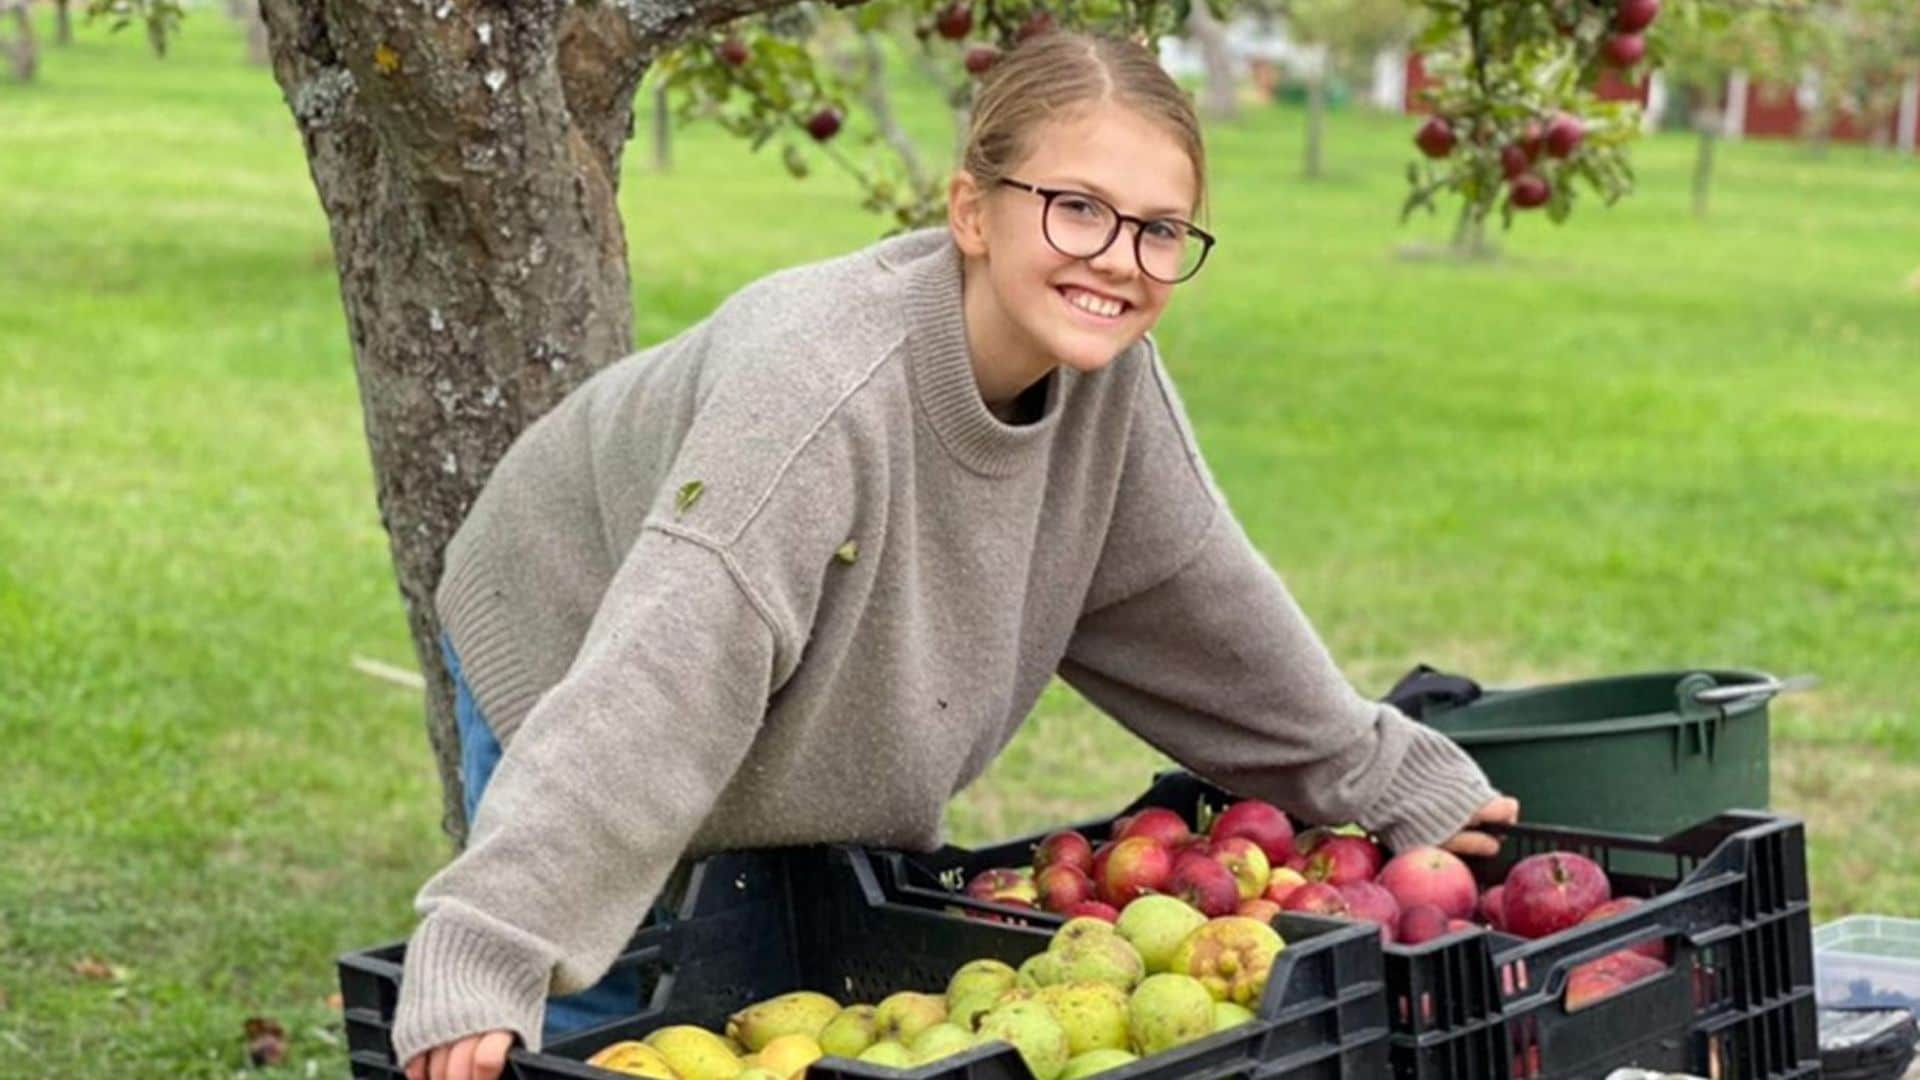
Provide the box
[394,525,789,1063]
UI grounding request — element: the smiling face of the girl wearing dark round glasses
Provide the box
[948,104,1198,390]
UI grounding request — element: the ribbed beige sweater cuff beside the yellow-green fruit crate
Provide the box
[394,911,553,1067]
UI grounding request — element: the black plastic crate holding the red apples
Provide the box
[872,773,1820,1080]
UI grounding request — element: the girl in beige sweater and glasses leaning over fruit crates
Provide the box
[394,33,1517,1080]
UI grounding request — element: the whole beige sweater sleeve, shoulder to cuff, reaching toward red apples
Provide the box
[1060,342,1494,847]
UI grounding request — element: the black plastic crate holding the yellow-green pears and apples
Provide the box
[340,847,1388,1080]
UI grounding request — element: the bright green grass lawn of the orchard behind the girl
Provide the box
[0,10,1920,1078]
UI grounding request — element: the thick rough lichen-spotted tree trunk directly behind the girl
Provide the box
[263,0,817,844]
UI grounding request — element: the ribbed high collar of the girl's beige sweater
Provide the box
[900,229,1079,477]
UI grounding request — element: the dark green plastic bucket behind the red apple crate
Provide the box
[1423,671,1789,836]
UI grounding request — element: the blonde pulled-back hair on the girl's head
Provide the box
[960,31,1206,215]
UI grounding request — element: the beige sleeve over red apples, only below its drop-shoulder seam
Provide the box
[1060,505,1494,847]
